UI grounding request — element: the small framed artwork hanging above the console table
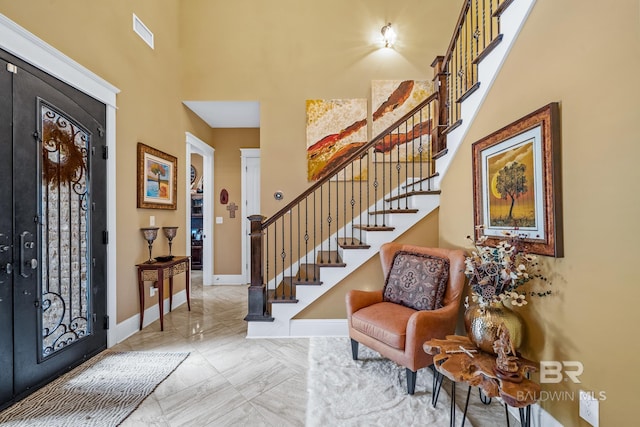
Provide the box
[138,142,178,209]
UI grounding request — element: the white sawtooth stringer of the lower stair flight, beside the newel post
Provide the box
[247,195,440,338]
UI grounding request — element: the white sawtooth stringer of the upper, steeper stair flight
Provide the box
[434,0,536,188]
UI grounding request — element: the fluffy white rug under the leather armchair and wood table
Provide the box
[306,338,517,427]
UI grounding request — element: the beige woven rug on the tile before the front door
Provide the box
[0,350,189,427]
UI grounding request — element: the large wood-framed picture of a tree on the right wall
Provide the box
[472,102,563,257]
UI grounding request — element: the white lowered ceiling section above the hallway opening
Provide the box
[182,101,260,128]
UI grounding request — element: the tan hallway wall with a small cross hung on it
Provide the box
[212,129,260,276]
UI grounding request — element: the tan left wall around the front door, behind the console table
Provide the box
[0,0,215,322]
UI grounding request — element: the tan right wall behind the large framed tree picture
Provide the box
[440,0,640,426]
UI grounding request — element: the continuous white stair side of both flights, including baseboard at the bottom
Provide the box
[247,0,535,338]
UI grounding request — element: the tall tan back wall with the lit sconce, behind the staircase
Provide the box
[181,0,461,221]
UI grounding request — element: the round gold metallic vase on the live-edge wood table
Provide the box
[464,302,524,354]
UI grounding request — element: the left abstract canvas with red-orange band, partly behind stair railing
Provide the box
[306,99,367,181]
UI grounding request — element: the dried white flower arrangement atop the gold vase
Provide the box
[464,226,551,307]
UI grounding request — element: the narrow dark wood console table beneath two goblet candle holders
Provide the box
[136,256,191,331]
